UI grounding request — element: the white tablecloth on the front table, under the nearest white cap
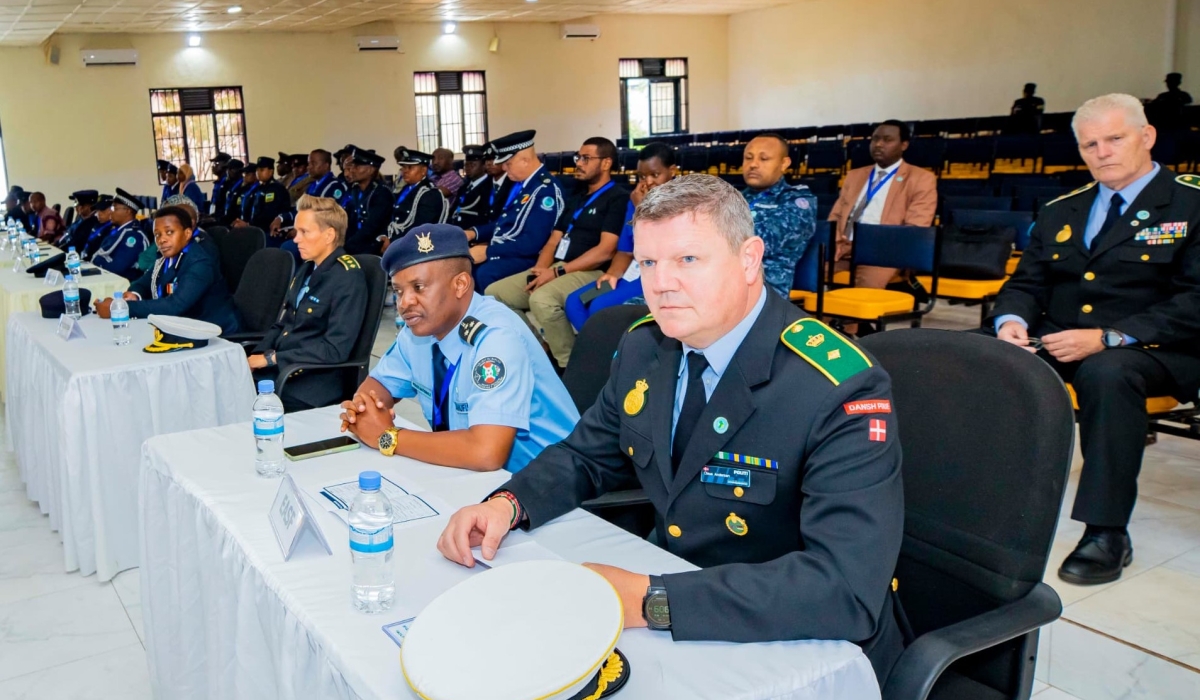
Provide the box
[139,408,880,700]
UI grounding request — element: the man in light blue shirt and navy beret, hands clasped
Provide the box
[342,223,580,472]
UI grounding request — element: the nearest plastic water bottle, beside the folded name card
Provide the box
[349,472,396,612]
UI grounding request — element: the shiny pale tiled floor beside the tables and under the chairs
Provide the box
[0,302,1200,700]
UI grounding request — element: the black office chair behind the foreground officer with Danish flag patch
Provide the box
[862,329,1074,700]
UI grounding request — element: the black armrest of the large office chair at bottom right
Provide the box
[883,584,1062,700]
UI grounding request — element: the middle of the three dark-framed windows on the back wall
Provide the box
[413,71,487,154]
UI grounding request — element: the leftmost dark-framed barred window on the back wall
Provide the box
[150,88,250,183]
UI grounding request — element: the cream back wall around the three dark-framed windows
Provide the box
[0,16,728,204]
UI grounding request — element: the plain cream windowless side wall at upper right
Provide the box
[730,0,1176,128]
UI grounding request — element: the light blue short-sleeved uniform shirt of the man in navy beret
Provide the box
[371,294,580,472]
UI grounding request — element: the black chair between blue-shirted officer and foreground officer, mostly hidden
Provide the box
[563,305,654,538]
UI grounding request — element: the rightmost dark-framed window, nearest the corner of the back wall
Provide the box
[618,59,688,140]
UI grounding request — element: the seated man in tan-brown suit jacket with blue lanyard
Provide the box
[829,119,937,289]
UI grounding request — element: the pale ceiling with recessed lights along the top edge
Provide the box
[0,0,791,46]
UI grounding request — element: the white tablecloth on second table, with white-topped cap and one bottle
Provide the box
[5,313,254,581]
